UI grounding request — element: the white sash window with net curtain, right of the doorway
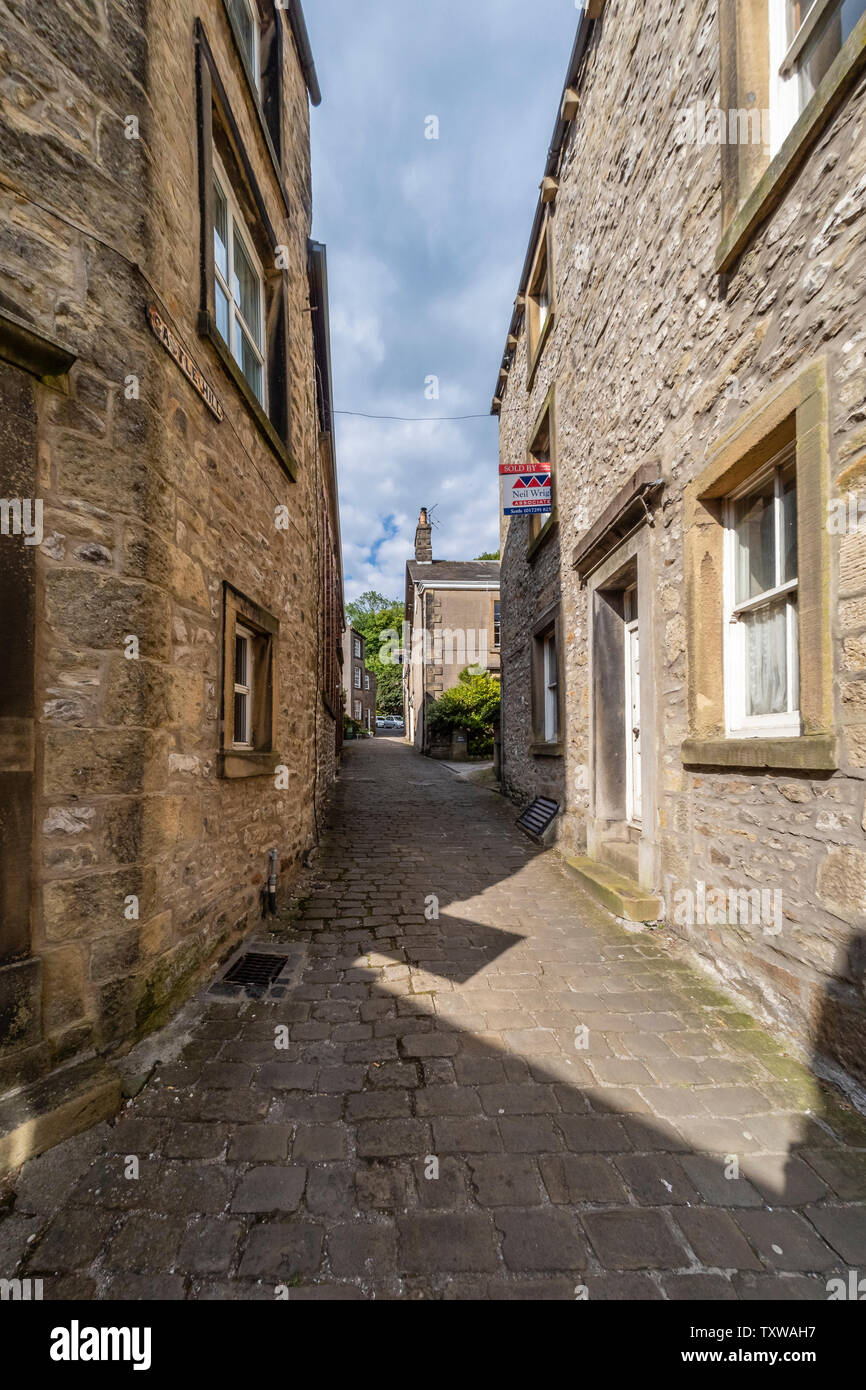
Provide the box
[724,445,801,735]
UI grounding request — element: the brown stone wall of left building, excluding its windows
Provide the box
[0,0,334,1084]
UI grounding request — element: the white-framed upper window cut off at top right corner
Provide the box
[767,0,866,154]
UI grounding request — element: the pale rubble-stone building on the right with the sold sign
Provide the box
[493,0,866,1079]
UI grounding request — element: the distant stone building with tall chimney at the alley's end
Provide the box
[403,507,499,752]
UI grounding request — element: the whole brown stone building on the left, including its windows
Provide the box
[0,0,342,1163]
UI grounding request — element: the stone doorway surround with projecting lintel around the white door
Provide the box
[573,463,662,892]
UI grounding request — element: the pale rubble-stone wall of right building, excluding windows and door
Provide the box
[500,0,866,1076]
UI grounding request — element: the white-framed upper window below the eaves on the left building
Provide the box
[214,154,267,409]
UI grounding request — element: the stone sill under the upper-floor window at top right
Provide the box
[716,15,866,274]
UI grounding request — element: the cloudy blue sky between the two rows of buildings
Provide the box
[304,0,578,599]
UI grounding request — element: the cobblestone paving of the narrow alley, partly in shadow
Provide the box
[6,739,866,1300]
